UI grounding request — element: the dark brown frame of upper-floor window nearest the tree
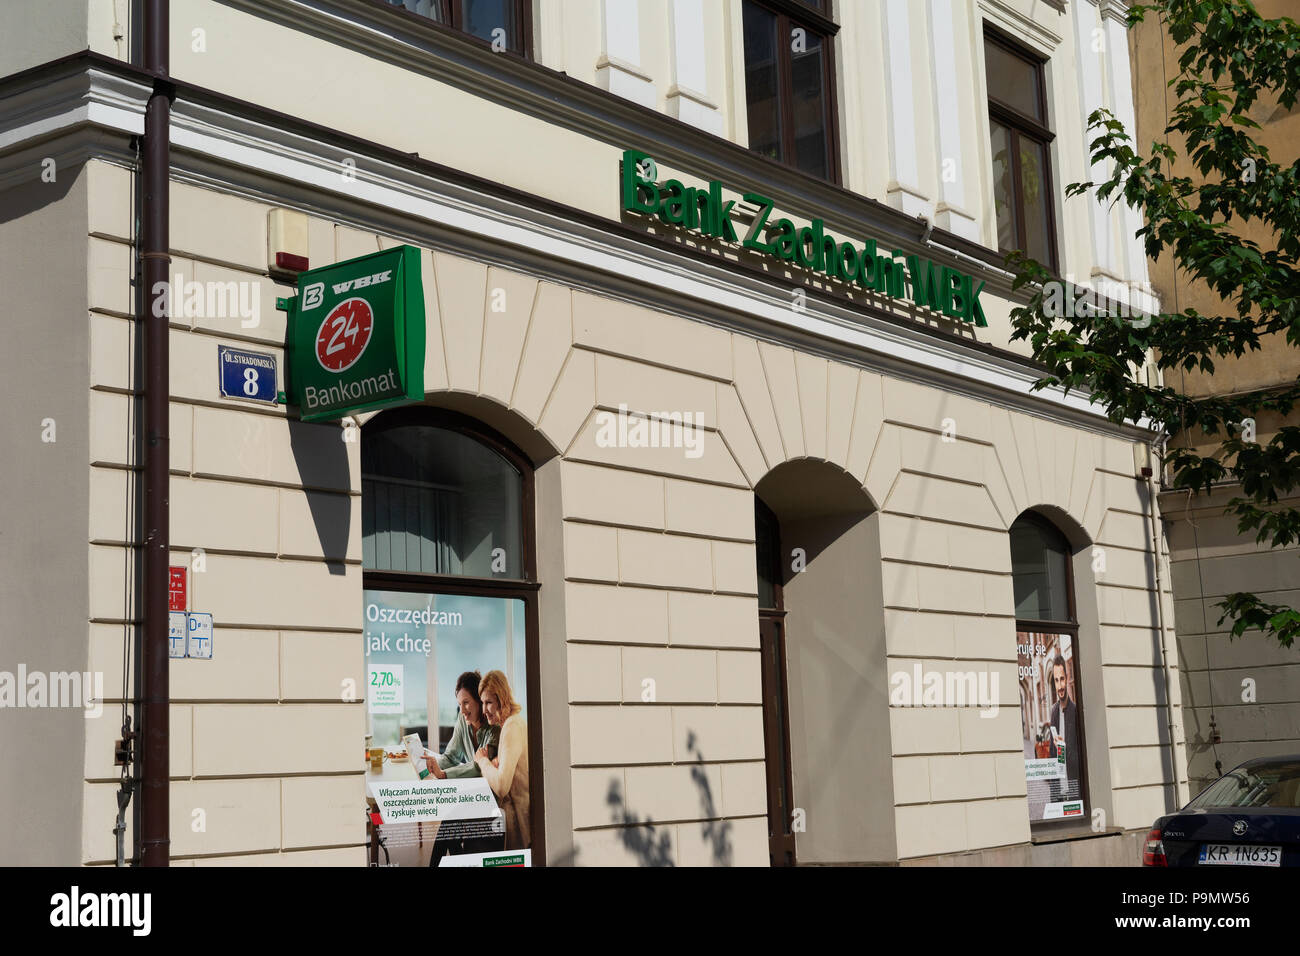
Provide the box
[984,22,1061,273]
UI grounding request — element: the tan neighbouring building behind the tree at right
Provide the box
[1131,0,1300,792]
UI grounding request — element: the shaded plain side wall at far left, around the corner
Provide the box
[0,152,92,866]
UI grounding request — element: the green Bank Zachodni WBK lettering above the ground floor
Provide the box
[623,150,988,328]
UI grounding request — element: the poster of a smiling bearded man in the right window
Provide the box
[1015,631,1088,822]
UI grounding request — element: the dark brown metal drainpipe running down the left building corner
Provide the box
[138,0,172,866]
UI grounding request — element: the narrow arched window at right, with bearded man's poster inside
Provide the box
[1010,511,1088,829]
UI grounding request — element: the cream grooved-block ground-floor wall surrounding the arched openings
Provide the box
[65,164,1182,864]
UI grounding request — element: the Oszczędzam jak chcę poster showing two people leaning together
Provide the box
[363,591,532,866]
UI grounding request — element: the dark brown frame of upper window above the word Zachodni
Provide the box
[741,0,842,186]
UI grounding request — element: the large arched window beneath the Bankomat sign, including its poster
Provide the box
[361,407,542,865]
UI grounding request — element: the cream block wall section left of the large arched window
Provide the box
[81,163,365,865]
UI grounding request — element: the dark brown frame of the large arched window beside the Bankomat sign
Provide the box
[360,405,546,866]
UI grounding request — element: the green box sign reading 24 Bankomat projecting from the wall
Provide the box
[277,246,424,421]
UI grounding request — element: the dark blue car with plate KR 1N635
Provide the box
[1141,754,1300,866]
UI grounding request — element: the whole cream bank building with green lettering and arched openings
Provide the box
[0,0,1187,865]
